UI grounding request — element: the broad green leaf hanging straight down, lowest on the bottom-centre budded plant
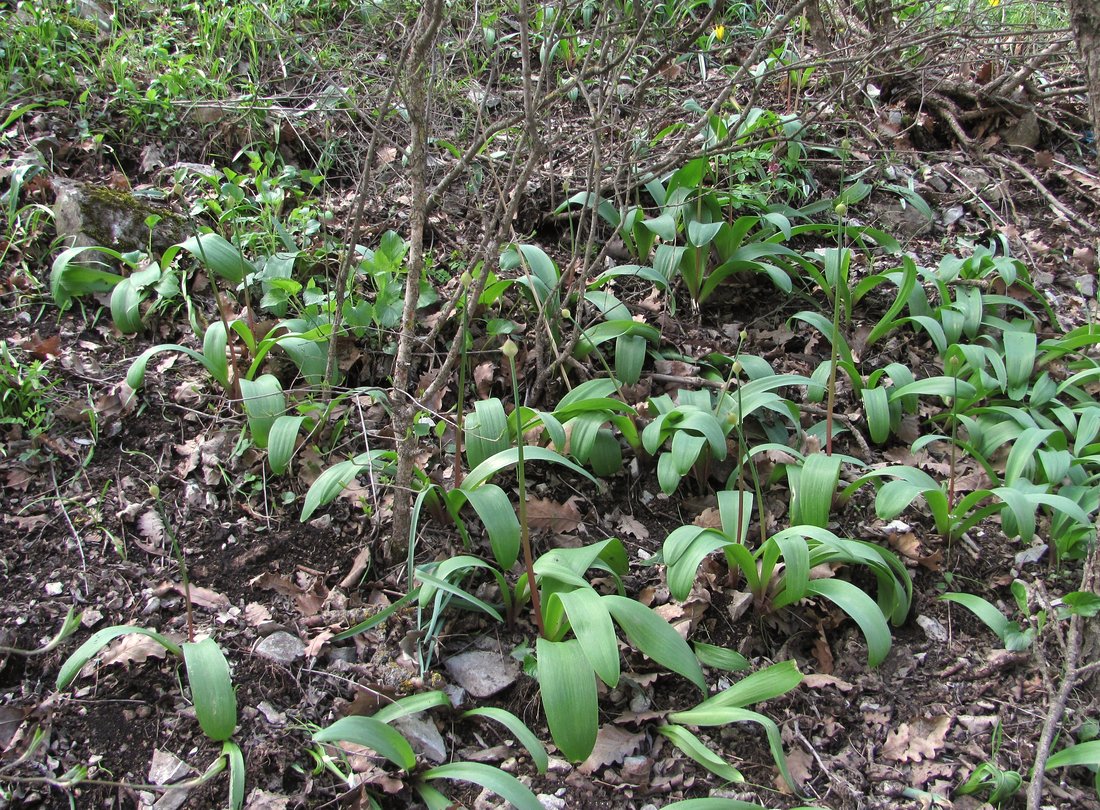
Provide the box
[536,638,600,762]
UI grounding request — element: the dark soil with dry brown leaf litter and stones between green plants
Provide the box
[0,1,1100,810]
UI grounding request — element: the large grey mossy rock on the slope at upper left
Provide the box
[53,178,194,254]
